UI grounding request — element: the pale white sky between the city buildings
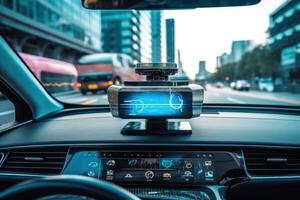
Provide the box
[163,0,285,78]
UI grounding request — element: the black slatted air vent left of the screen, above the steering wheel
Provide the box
[1,147,68,175]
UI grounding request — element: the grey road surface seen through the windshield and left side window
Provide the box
[0,86,300,129]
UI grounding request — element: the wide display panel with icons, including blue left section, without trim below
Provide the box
[63,150,240,185]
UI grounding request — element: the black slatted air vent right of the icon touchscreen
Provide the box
[244,149,300,176]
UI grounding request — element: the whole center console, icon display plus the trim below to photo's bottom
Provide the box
[63,148,242,200]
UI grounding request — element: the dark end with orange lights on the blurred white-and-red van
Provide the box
[78,72,113,95]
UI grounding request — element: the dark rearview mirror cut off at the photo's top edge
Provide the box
[82,0,261,10]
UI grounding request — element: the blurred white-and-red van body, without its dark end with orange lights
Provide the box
[76,53,141,84]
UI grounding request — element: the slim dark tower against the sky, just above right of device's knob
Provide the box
[166,19,175,62]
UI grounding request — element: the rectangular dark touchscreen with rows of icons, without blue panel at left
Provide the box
[101,152,215,183]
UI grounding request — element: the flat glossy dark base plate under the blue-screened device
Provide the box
[121,120,192,135]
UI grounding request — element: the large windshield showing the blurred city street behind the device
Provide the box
[0,0,300,106]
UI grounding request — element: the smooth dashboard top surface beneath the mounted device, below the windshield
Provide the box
[0,113,300,147]
